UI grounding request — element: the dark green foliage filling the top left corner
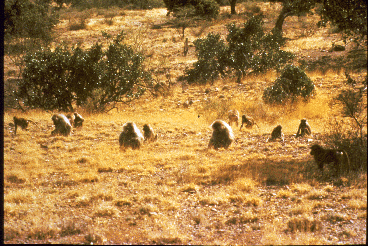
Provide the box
[4,0,58,40]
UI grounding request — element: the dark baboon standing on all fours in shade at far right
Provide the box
[310,144,350,174]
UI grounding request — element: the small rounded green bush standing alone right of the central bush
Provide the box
[263,65,314,104]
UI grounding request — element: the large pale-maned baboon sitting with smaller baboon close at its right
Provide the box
[119,122,144,149]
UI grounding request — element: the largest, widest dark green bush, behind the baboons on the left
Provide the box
[16,31,151,111]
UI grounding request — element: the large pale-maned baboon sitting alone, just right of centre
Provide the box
[208,120,234,150]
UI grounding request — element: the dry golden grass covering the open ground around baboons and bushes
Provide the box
[4,3,367,244]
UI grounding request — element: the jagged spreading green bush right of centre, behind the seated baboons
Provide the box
[180,16,293,83]
